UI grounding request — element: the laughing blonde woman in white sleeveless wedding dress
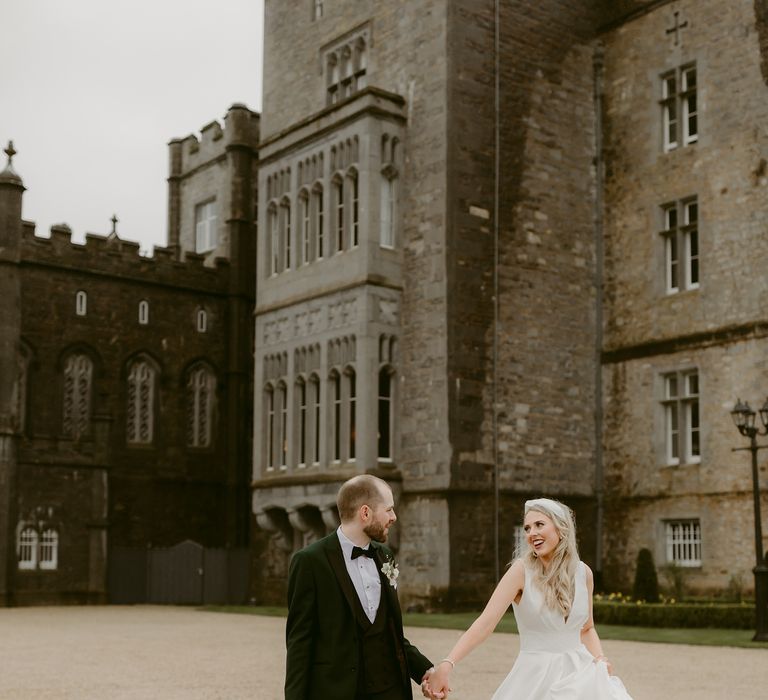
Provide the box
[425,498,632,700]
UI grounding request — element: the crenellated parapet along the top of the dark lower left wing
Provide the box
[21,221,230,293]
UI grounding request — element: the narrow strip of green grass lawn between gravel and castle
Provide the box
[201,605,768,649]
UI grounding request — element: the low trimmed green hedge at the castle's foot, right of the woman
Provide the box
[593,600,755,630]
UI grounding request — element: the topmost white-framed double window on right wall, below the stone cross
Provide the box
[661,65,699,151]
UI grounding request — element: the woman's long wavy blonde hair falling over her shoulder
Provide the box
[516,498,579,617]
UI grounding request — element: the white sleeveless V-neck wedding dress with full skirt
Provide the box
[493,562,632,700]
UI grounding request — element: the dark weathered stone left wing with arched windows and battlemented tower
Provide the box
[0,105,258,604]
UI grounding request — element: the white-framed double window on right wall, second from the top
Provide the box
[661,197,699,294]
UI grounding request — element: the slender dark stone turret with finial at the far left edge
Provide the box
[0,141,25,605]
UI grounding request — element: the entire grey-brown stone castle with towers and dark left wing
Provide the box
[0,0,768,607]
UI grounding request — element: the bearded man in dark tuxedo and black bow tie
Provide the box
[285,474,434,700]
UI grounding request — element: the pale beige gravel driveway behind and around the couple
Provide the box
[0,606,768,700]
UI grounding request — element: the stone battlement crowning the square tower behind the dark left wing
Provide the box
[168,104,260,177]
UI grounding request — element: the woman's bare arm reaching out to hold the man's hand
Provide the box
[429,559,525,697]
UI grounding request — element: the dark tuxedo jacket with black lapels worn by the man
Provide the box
[285,532,432,700]
